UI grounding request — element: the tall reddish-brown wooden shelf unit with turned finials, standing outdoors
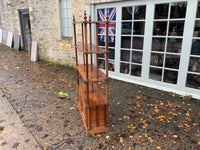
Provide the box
[73,11,109,133]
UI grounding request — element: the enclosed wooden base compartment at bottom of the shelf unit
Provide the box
[78,97,109,134]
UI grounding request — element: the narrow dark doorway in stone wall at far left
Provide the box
[19,9,31,51]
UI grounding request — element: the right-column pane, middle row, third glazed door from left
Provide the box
[167,38,182,53]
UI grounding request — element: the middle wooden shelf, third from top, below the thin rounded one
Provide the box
[76,64,106,82]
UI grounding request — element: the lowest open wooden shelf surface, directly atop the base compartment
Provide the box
[78,83,107,107]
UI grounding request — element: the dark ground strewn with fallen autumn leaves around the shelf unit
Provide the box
[0,45,200,150]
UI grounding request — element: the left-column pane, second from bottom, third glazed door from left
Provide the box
[150,53,164,67]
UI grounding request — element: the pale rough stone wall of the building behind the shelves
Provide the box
[0,0,126,64]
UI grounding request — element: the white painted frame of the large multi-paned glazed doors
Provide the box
[91,0,200,99]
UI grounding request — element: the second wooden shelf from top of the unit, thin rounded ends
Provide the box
[77,44,108,54]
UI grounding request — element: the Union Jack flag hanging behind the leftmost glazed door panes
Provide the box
[98,8,116,42]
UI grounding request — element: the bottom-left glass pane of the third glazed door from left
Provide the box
[149,67,162,81]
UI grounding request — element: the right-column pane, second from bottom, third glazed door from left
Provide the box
[165,54,180,69]
